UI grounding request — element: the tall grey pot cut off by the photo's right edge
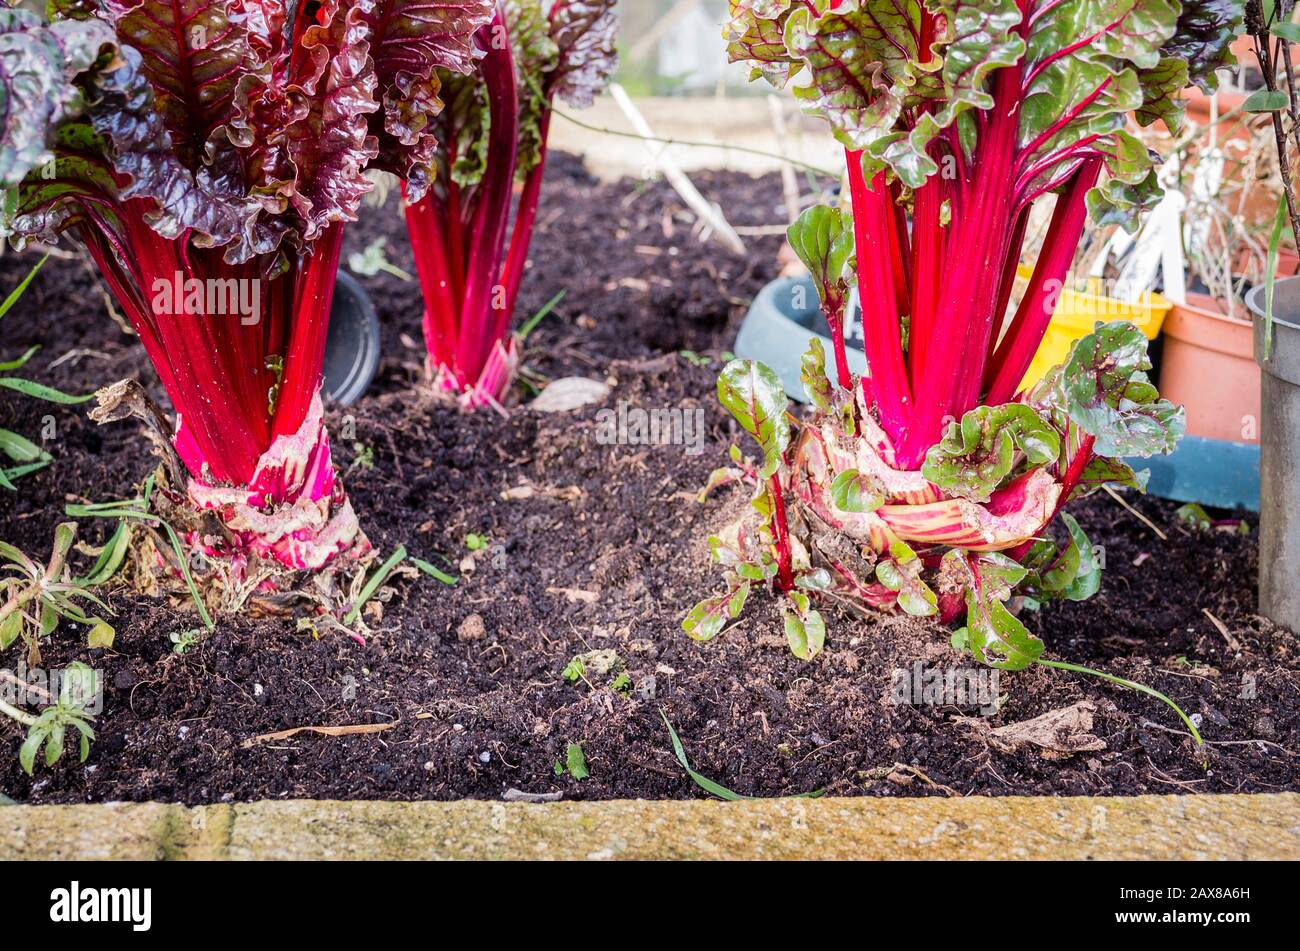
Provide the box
[1237,278,1300,631]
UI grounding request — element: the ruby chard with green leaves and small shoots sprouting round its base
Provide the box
[685,0,1240,706]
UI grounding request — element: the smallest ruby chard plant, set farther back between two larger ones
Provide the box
[406,0,618,408]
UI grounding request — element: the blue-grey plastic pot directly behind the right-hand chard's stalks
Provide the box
[736,277,867,403]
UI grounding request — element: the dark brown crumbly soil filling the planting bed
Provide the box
[0,160,1300,803]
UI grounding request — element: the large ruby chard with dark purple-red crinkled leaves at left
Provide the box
[0,0,491,570]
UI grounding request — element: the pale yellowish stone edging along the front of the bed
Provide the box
[0,793,1300,861]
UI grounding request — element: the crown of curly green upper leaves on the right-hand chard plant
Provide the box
[725,0,1243,220]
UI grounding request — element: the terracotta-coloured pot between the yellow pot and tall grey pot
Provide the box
[1160,294,1260,443]
